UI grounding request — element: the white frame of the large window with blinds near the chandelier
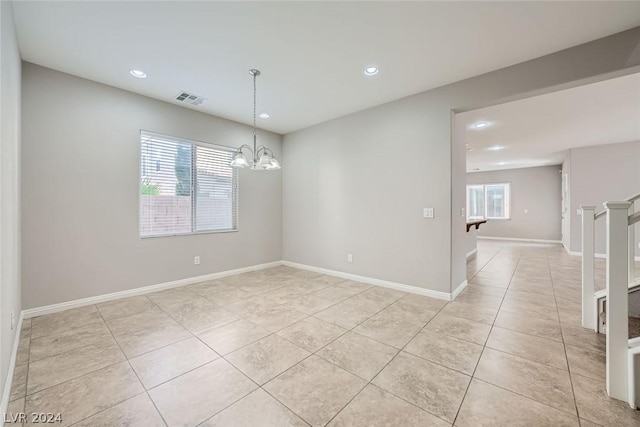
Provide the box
[138,129,240,239]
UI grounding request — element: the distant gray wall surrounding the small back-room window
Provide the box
[467,165,562,241]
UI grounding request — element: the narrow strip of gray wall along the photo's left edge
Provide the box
[0,1,21,406]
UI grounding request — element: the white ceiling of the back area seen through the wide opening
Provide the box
[456,73,640,172]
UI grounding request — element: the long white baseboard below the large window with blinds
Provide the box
[22,261,282,319]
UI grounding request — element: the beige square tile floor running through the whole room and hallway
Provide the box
[9,242,640,427]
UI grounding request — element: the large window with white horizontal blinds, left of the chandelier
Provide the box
[140,131,238,237]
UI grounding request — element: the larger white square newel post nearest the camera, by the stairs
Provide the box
[604,202,631,400]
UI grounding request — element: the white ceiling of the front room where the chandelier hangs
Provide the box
[14,1,640,133]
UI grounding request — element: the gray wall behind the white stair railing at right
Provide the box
[565,141,640,256]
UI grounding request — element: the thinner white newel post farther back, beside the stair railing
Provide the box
[580,206,598,332]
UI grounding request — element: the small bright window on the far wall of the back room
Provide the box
[467,183,511,221]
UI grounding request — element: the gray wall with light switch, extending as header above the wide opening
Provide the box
[283,29,640,292]
